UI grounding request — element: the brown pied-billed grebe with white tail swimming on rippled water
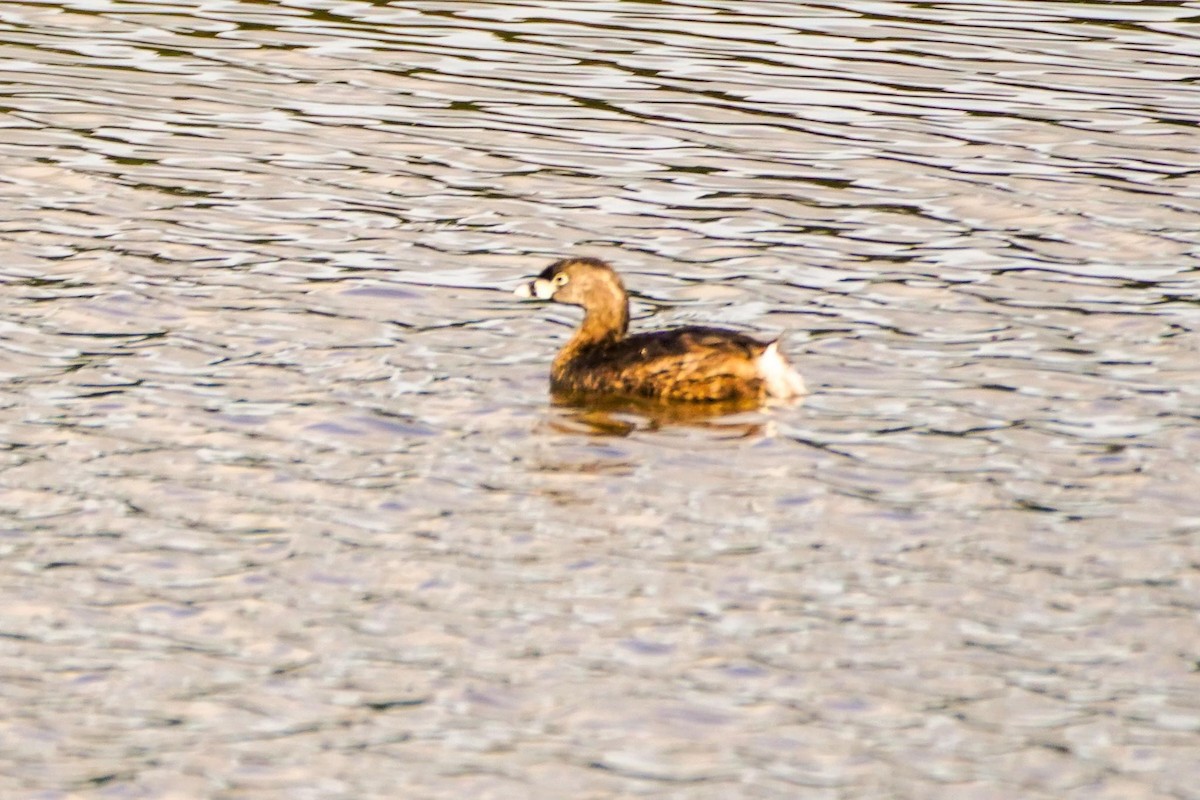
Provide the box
[515,258,805,403]
